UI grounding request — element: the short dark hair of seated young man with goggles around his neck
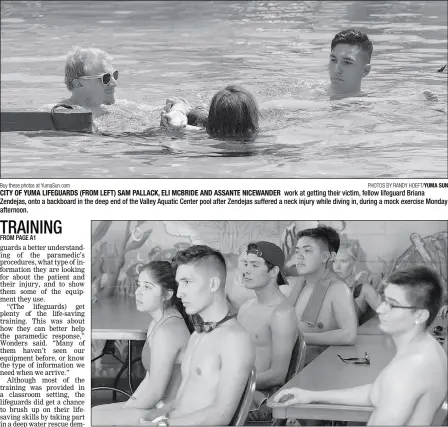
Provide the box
[171,245,227,290]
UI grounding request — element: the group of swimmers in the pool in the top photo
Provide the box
[58,29,438,137]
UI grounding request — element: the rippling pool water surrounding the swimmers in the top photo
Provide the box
[1,1,447,178]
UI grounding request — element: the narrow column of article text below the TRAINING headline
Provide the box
[0,244,86,427]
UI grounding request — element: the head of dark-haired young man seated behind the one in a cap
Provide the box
[295,226,340,276]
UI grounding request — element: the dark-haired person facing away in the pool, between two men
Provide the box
[161,85,260,137]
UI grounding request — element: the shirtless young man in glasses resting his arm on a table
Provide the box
[273,266,447,426]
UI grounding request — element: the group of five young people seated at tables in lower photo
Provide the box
[92,226,447,426]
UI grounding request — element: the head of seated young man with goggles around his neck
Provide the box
[171,245,227,315]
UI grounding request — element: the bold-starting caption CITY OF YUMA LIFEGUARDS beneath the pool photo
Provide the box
[0,182,448,212]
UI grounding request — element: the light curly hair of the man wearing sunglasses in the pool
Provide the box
[64,46,112,92]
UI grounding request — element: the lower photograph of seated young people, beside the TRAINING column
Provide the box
[91,220,448,426]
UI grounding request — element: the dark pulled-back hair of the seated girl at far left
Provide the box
[140,261,194,333]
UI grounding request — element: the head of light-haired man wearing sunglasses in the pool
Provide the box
[65,46,118,107]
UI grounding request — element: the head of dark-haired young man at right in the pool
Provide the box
[328,29,373,94]
